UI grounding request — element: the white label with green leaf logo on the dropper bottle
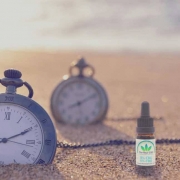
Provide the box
[136,139,156,166]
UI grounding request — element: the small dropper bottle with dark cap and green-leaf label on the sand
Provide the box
[136,102,156,167]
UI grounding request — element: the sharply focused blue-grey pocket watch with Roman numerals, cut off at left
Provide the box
[0,69,56,165]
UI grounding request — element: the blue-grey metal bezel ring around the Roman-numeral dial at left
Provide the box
[0,93,57,164]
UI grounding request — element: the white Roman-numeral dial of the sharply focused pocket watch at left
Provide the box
[0,103,44,165]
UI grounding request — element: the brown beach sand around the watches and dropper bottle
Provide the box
[0,51,180,180]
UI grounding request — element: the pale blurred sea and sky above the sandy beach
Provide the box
[0,0,180,52]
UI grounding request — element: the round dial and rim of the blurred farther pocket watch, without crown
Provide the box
[52,78,107,124]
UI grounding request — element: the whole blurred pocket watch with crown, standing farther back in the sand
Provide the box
[51,58,108,124]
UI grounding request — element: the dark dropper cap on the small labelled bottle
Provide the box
[136,101,154,134]
